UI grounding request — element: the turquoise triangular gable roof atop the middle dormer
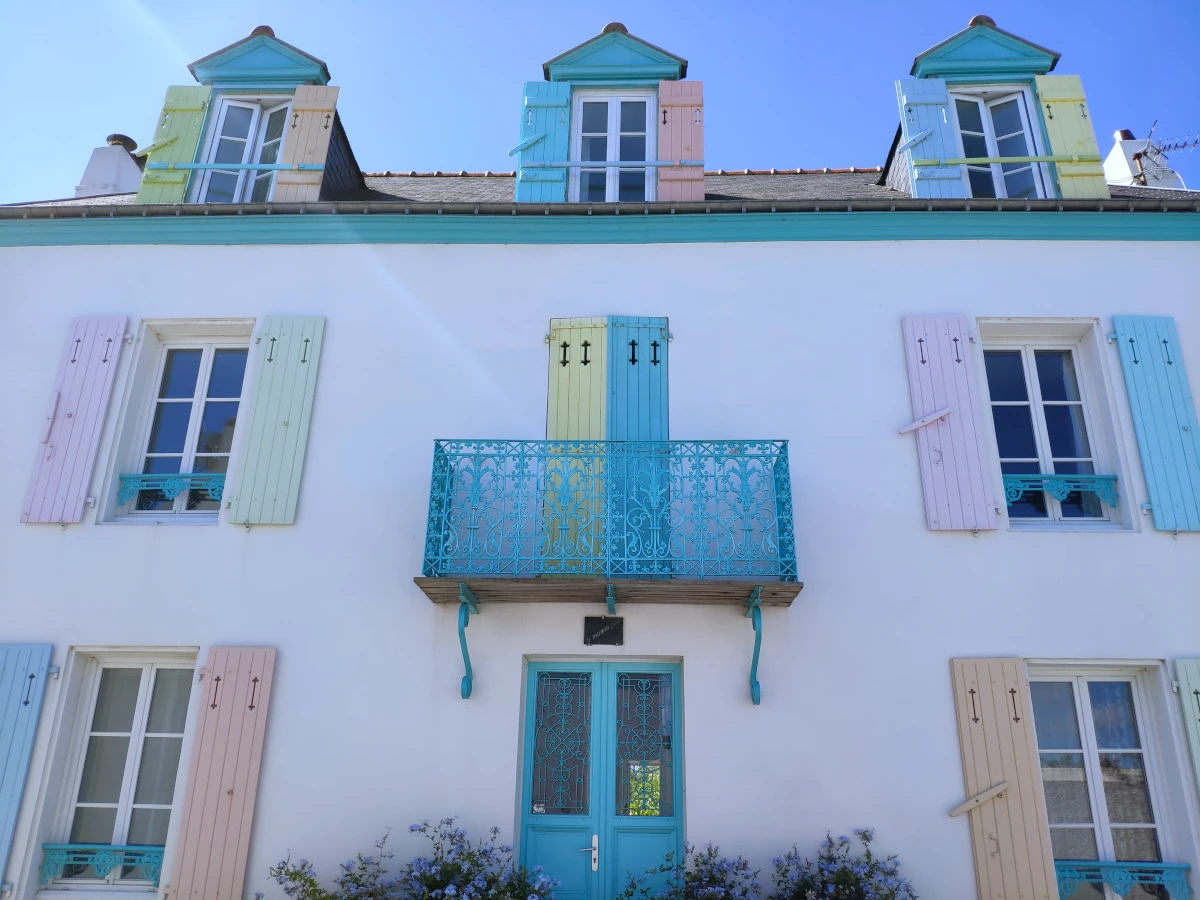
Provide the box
[541,22,688,84]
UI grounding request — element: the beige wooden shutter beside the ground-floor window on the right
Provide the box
[950,659,1058,900]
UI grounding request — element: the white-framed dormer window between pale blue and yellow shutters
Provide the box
[952,91,1049,198]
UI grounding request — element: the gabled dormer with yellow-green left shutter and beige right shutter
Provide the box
[138,25,364,203]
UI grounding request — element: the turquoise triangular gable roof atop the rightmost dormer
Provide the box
[912,16,1061,83]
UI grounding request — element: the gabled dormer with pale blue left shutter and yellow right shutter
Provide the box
[888,16,1109,199]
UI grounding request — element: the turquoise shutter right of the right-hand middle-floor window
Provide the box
[1112,316,1200,532]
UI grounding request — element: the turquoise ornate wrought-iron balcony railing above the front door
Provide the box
[424,440,796,581]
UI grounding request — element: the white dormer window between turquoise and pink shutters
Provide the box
[570,91,656,203]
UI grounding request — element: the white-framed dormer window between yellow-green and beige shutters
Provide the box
[196,97,289,203]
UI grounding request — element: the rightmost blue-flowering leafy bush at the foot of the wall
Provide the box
[770,828,917,900]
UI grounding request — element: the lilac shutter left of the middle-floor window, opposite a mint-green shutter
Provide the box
[20,316,126,522]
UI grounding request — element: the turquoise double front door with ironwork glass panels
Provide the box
[521,661,683,900]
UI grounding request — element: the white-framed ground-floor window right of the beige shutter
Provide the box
[1030,676,1168,900]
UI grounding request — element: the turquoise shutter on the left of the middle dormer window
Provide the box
[509,82,571,203]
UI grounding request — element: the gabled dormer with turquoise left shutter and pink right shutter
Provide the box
[509,22,704,203]
